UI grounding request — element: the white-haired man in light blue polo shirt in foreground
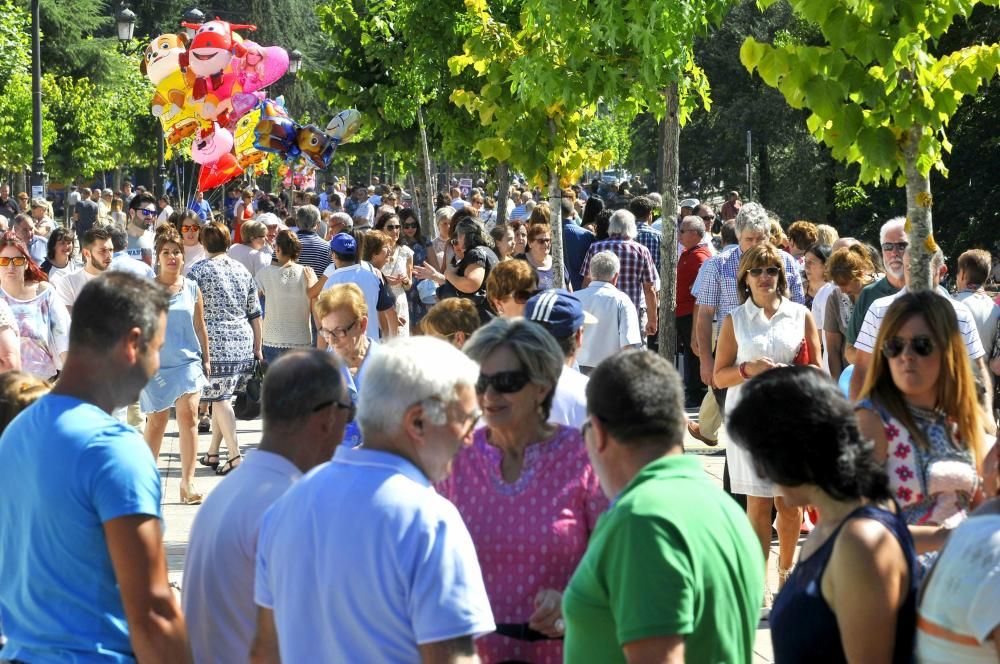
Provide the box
[251,336,495,662]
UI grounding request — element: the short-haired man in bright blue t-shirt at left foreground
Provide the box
[0,272,191,662]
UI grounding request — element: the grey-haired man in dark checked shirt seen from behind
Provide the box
[580,210,660,337]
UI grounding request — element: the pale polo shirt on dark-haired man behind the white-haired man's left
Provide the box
[181,450,302,662]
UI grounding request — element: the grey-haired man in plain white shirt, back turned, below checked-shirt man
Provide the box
[574,251,642,376]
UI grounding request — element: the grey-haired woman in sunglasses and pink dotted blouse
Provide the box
[438,319,607,664]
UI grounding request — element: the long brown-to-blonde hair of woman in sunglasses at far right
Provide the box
[861,291,985,467]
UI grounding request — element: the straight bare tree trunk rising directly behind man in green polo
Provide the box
[659,83,681,364]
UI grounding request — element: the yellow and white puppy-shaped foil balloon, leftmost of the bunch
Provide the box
[139,34,201,145]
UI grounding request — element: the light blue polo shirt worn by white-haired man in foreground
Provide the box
[254,446,496,663]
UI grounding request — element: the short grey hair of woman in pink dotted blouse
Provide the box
[460,318,566,420]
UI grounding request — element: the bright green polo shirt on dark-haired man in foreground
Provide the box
[563,455,764,664]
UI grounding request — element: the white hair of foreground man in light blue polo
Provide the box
[357,336,479,437]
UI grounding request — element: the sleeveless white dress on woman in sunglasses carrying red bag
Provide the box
[722,297,809,498]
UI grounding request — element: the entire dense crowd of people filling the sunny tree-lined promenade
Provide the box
[0,176,1000,663]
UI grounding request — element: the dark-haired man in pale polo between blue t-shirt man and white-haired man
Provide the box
[183,350,354,662]
